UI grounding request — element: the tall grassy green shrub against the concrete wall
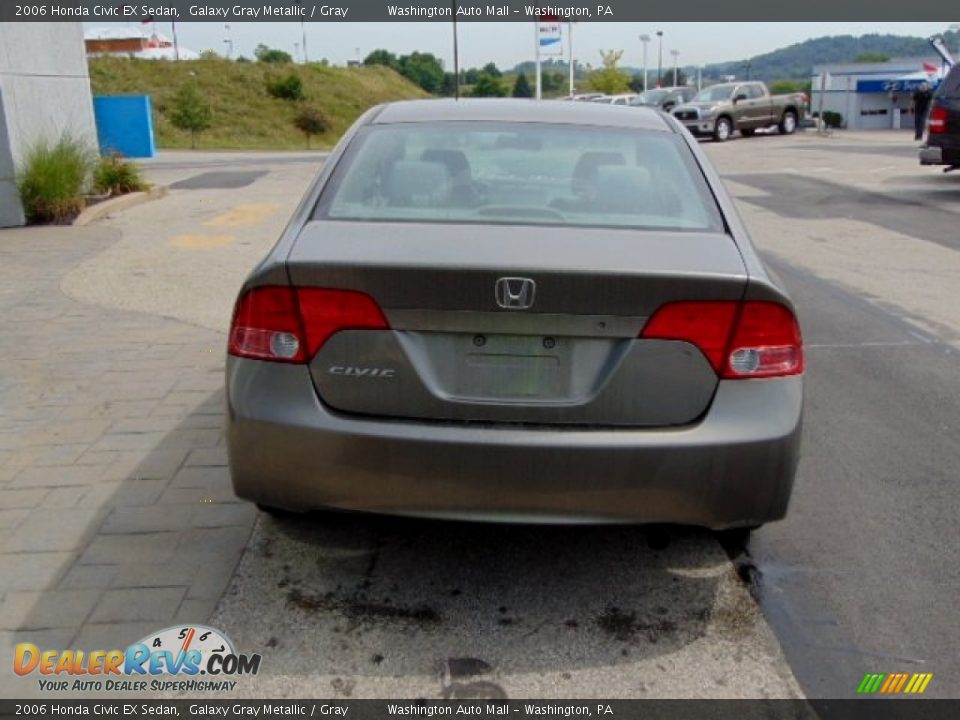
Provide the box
[17,134,93,223]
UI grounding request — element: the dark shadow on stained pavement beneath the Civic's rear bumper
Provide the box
[213,504,758,697]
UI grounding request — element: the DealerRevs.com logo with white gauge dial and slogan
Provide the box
[13,625,260,692]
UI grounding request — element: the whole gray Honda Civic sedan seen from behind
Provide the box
[226,100,804,529]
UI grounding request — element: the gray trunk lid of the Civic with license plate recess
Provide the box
[288,221,747,427]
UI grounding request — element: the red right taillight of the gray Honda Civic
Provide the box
[640,300,803,379]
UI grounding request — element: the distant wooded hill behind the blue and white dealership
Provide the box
[703,32,958,82]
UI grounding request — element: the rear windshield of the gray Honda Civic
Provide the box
[315,122,723,231]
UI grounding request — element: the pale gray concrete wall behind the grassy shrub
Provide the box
[0,22,97,227]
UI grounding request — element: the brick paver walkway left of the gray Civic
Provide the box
[0,227,256,695]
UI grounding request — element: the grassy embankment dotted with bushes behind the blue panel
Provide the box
[89,57,426,149]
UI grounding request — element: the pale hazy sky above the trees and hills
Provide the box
[84,21,953,68]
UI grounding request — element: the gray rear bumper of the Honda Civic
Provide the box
[227,357,803,529]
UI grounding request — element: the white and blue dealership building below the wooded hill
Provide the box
[810,55,943,130]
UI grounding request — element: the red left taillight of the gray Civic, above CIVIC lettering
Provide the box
[228,286,388,363]
